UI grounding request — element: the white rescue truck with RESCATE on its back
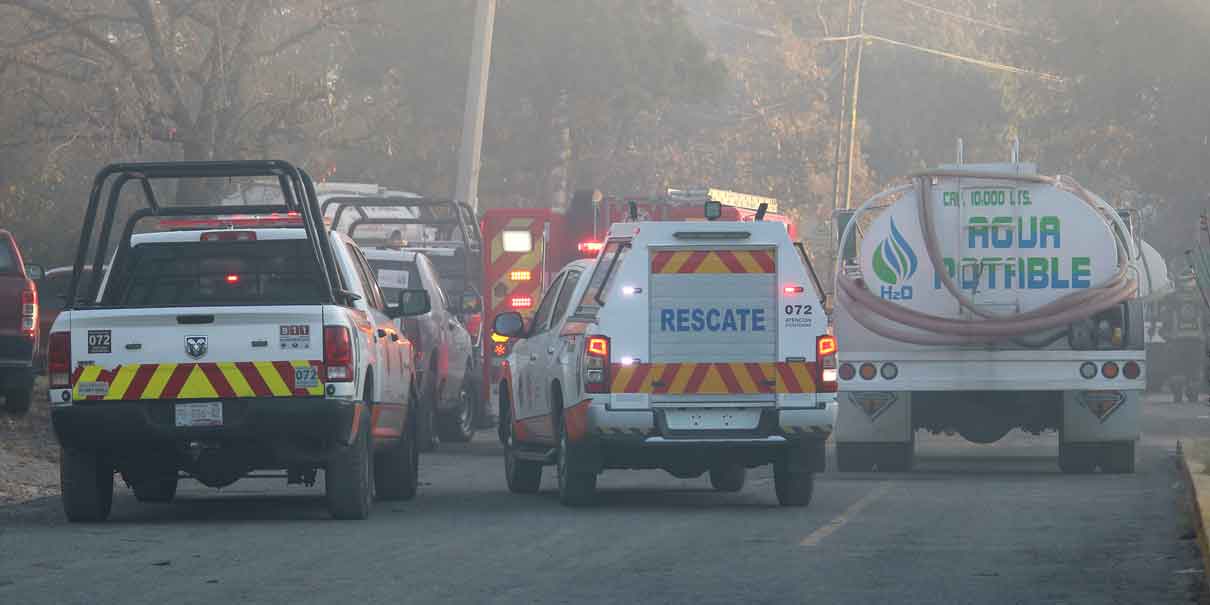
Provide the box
[495,206,836,506]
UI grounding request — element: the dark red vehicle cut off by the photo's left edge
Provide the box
[0,230,42,414]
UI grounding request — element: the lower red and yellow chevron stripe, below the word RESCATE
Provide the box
[610,362,816,394]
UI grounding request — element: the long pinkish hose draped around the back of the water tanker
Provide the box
[836,171,1137,345]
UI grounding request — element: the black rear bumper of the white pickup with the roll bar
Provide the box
[51,397,360,450]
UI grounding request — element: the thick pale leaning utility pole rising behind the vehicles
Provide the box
[454,0,496,213]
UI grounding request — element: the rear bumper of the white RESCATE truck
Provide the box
[569,402,836,472]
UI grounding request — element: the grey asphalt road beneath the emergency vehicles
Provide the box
[0,394,1210,605]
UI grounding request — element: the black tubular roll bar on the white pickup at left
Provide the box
[67,160,350,309]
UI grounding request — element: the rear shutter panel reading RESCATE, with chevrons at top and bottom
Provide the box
[649,247,778,404]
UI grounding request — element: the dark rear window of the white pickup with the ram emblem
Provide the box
[105,240,327,306]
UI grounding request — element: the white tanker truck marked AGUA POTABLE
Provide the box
[834,157,1166,473]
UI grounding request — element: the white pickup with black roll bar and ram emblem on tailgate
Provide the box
[47,162,430,522]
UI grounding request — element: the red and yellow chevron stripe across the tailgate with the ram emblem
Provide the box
[71,361,324,401]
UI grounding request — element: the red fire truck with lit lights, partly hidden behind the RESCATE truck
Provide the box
[480,188,797,428]
